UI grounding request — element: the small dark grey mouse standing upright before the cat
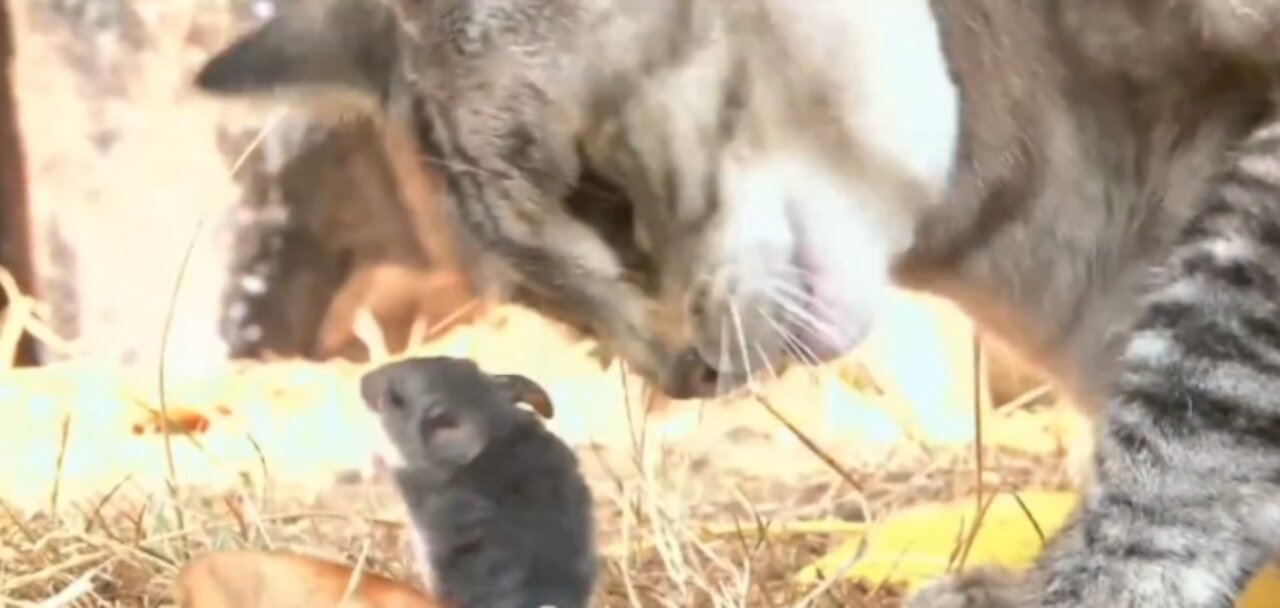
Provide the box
[360,357,598,608]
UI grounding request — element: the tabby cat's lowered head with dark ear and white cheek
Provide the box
[197,0,957,397]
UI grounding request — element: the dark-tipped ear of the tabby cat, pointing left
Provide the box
[195,0,397,105]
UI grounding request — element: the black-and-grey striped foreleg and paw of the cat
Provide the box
[906,95,1280,608]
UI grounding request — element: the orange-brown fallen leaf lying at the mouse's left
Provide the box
[173,550,442,608]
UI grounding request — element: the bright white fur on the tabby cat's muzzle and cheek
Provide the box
[719,0,960,358]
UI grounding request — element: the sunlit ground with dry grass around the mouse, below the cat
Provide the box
[0,288,1090,607]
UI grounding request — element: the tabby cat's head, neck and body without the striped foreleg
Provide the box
[197,0,1280,605]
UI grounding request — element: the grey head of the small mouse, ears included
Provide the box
[360,357,554,471]
